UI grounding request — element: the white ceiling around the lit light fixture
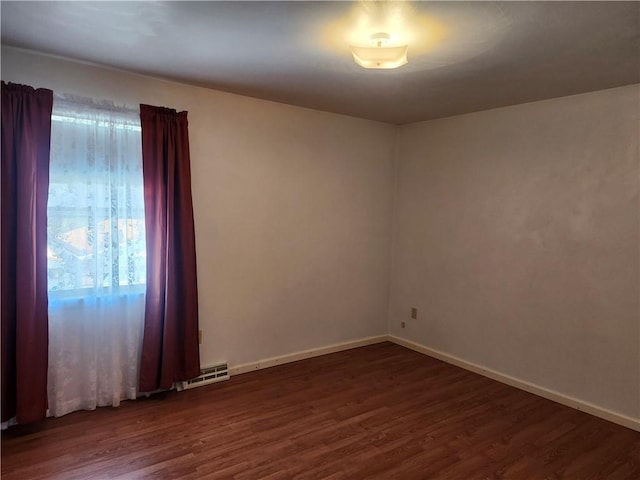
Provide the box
[0,0,640,124]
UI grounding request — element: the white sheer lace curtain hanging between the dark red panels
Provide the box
[47,97,146,416]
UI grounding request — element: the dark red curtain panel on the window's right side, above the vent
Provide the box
[140,105,200,392]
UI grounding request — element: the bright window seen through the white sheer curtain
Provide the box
[47,98,146,297]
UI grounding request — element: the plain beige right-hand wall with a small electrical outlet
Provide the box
[389,85,640,419]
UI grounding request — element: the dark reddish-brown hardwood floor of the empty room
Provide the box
[2,343,640,480]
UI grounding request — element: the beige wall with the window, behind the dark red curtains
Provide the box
[2,48,397,365]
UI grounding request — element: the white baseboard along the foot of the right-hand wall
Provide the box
[388,335,640,432]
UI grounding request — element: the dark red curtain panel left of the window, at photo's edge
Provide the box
[0,82,53,423]
